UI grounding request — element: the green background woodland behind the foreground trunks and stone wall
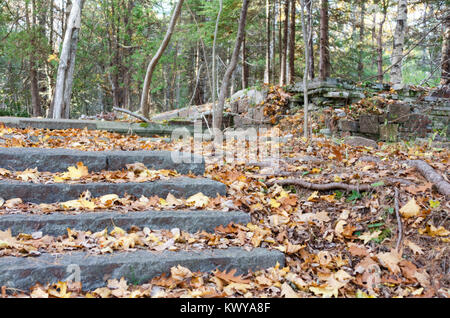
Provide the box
[0,0,448,118]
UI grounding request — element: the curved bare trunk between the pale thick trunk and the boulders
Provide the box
[140,0,184,118]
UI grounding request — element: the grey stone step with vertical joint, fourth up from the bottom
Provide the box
[0,147,205,175]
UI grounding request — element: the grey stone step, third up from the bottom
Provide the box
[0,177,227,203]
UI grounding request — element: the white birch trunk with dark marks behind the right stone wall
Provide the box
[391,0,408,84]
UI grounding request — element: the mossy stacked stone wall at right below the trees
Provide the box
[288,79,450,141]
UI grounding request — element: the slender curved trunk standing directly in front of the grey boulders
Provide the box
[213,0,250,131]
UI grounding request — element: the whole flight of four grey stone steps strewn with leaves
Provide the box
[0,148,285,291]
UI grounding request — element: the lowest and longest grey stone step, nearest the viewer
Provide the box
[0,248,285,290]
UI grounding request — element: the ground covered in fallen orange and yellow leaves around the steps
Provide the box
[0,118,450,298]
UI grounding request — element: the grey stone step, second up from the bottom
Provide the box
[0,210,251,236]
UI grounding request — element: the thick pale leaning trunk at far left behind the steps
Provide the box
[53,0,84,119]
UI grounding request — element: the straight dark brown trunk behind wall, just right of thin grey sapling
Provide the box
[319,0,330,80]
